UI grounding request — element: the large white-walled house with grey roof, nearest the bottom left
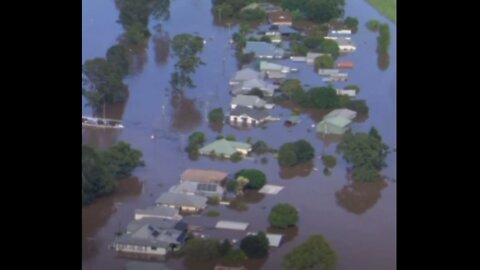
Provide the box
[112,218,188,259]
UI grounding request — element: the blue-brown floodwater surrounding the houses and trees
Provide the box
[82,0,396,270]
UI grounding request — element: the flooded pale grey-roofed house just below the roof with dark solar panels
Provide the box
[155,192,207,212]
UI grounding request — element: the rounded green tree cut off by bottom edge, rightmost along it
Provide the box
[282,235,337,270]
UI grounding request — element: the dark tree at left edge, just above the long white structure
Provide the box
[82,58,128,110]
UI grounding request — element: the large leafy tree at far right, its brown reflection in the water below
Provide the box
[337,130,389,182]
